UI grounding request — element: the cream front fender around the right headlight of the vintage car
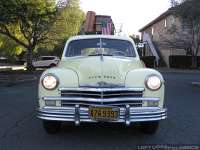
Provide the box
[125,68,165,108]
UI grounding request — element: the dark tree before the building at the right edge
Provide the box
[168,0,200,67]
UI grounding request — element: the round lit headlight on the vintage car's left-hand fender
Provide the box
[42,74,59,90]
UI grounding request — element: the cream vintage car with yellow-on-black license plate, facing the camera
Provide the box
[37,35,167,133]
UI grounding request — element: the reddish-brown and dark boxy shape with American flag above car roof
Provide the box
[81,11,115,35]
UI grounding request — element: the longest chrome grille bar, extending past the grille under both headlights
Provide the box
[42,96,160,103]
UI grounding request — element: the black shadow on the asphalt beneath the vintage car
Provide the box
[59,123,157,140]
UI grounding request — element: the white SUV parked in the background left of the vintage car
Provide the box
[25,56,60,68]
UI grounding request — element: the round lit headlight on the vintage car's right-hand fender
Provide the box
[146,75,162,91]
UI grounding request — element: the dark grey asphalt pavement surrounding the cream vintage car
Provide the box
[0,73,200,150]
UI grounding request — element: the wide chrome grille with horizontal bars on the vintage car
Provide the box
[59,88,144,107]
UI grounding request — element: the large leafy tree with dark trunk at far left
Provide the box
[0,0,57,70]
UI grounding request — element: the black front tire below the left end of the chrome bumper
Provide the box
[43,120,61,134]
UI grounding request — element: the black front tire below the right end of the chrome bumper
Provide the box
[140,121,159,134]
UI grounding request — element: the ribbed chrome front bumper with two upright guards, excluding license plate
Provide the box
[38,105,167,125]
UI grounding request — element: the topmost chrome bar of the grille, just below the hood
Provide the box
[58,87,145,92]
